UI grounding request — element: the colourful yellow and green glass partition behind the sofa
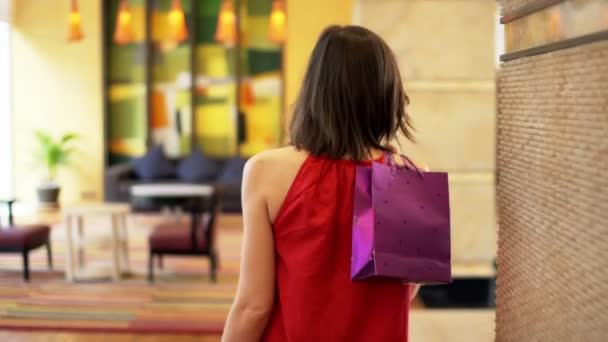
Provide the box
[104,0,283,164]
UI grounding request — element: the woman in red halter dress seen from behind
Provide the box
[223,26,415,342]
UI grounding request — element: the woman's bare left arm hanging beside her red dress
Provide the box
[222,157,275,342]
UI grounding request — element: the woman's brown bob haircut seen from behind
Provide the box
[289,26,414,160]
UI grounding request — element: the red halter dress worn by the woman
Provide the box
[262,156,409,342]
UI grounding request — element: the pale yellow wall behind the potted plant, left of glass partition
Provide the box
[11,0,104,203]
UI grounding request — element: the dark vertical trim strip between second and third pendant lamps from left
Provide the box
[144,0,154,148]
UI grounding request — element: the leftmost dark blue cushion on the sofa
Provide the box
[131,145,175,181]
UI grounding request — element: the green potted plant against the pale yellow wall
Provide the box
[36,131,78,208]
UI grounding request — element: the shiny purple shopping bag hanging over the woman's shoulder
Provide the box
[351,154,452,283]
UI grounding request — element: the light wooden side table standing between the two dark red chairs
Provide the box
[63,203,131,281]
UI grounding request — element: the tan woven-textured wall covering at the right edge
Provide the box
[496,40,608,342]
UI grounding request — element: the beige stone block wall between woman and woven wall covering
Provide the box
[355,0,497,268]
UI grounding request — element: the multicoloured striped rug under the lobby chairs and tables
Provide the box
[0,216,241,334]
